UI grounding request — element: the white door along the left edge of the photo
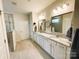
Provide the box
[0,14,7,59]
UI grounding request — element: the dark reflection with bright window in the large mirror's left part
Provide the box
[51,16,63,33]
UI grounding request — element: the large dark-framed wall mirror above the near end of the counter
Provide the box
[50,12,73,35]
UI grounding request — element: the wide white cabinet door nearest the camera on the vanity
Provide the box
[54,43,66,59]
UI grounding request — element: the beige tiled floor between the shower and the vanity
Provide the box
[11,40,52,59]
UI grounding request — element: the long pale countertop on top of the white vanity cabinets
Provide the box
[37,32,71,47]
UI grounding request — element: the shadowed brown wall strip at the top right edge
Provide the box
[72,0,79,29]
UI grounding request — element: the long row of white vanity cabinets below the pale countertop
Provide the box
[34,33,70,59]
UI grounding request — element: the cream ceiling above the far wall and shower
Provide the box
[12,0,55,13]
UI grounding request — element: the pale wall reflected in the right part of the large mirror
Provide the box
[62,13,73,35]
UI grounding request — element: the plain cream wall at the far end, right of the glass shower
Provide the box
[14,13,29,41]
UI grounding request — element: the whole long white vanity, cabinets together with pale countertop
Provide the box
[33,32,71,59]
